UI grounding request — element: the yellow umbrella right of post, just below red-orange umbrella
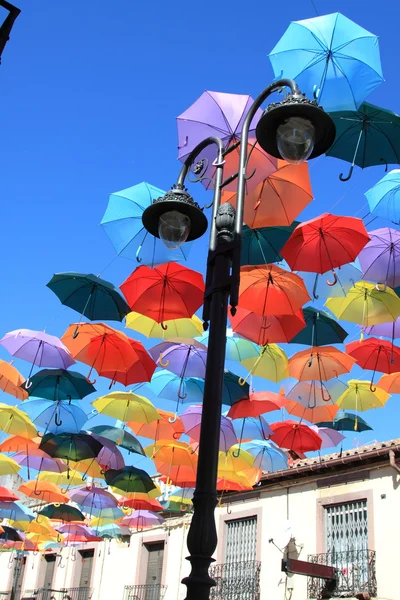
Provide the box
[239,344,289,385]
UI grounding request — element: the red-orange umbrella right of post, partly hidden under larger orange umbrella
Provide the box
[229,306,305,346]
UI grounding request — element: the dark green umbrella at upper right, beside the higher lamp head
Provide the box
[326,102,400,181]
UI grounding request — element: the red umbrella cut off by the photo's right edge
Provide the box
[346,338,400,391]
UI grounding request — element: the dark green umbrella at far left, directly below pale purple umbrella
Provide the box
[21,369,96,400]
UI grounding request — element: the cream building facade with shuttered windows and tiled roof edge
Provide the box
[0,439,400,600]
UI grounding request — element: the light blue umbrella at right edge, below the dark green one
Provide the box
[365,169,400,224]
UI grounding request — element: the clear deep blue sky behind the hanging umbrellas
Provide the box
[0,0,400,468]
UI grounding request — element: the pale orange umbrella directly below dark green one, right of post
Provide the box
[289,346,356,381]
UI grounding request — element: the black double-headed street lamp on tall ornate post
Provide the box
[142,79,335,600]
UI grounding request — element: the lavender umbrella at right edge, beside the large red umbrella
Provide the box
[358,227,400,289]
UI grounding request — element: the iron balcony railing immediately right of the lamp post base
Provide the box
[210,560,261,600]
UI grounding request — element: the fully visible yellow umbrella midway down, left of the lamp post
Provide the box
[92,392,160,423]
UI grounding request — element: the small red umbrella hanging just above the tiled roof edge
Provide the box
[269,420,322,454]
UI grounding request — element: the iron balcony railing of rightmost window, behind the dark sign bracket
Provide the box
[307,550,377,599]
